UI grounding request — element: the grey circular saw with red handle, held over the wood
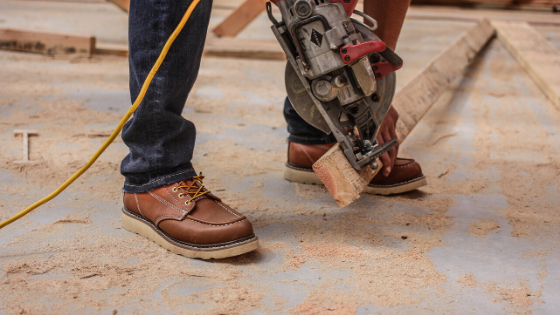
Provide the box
[267,0,403,171]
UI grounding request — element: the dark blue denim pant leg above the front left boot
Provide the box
[121,0,212,193]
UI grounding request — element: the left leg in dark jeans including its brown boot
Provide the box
[121,0,258,259]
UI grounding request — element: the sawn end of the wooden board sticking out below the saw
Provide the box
[313,143,383,207]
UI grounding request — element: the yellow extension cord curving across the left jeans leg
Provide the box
[0,0,200,229]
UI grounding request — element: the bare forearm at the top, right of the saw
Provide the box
[364,0,410,50]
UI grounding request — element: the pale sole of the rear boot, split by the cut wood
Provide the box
[284,165,428,196]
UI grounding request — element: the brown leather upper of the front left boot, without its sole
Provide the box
[123,180,253,245]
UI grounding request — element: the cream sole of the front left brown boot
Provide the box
[121,208,259,259]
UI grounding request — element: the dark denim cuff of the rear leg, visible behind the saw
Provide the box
[284,97,336,144]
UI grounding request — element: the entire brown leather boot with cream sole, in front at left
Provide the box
[122,173,259,259]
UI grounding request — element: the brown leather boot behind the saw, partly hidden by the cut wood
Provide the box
[284,142,428,195]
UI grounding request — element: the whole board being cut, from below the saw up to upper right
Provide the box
[313,20,494,207]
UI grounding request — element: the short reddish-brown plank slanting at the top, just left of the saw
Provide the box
[212,0,268,37]
